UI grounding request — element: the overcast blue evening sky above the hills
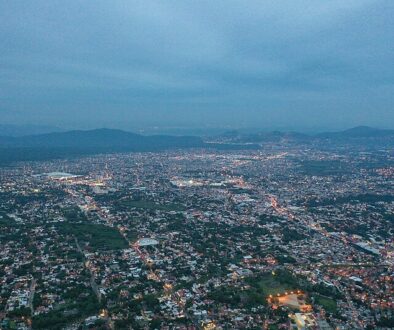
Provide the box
[0,0,394,130]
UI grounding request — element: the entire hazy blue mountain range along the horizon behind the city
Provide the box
[0,126,394,165]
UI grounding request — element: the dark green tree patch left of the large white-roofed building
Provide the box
[57,222,128,251]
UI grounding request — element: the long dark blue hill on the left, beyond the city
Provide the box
[0,129,204,164]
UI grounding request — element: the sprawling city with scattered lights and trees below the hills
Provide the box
[0,135,394,329]
